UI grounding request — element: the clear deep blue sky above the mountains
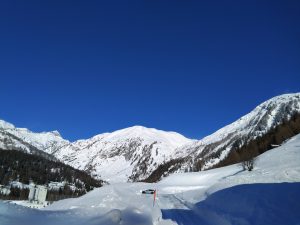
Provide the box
[0,0,300,140]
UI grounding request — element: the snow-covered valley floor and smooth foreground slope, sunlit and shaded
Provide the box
[0,135,300,225]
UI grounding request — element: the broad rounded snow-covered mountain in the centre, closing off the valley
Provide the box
[48,126,192,182]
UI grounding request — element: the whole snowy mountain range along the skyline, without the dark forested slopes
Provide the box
[0,93,300,182]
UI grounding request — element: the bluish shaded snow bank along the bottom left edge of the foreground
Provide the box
[0,202,153,225]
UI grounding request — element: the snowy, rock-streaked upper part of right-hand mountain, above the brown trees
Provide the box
[171,93,300,172]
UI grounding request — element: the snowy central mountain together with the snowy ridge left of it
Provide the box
[0,120,193,182]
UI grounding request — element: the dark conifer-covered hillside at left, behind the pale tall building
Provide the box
[0,149,103,201]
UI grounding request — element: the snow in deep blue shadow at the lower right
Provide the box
[162,183,300,225]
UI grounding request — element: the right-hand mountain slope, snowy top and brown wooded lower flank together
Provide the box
[146,93,300,181]
